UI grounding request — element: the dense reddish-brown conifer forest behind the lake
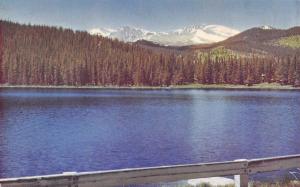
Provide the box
[0,21,300,86]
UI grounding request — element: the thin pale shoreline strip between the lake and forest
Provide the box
[0,83,300,90]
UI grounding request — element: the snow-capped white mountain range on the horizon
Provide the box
[89,25,239,46]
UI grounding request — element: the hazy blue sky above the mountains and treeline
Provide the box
[0,0,300,31]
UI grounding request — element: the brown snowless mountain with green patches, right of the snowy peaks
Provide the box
[185,26,300,55]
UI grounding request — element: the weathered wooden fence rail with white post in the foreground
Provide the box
[0,155,300,187]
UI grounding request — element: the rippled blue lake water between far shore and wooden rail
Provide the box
[0,89,300,178]
